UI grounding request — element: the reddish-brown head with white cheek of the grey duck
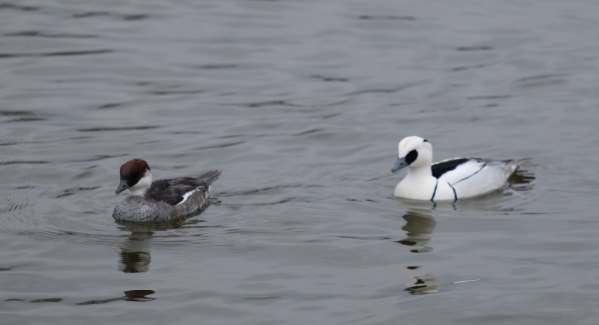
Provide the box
[115,159,152,196]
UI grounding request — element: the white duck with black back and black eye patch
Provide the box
[391,136,518,202]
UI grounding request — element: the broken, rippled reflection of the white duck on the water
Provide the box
[396,209,439,295]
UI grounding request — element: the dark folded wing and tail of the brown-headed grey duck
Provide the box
[146,170,220,205]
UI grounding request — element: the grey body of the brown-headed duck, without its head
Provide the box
[112,171,220,224]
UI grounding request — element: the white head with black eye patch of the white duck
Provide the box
[391,136,433,173]
